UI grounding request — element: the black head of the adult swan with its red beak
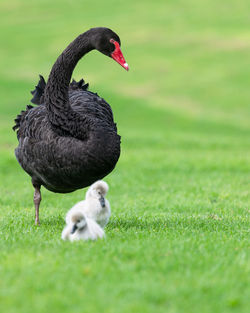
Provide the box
[91,27,129,71]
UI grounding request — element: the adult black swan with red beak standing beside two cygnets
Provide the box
[13,27,128,225]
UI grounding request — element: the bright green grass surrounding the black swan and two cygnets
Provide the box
[0,0,250,313]
